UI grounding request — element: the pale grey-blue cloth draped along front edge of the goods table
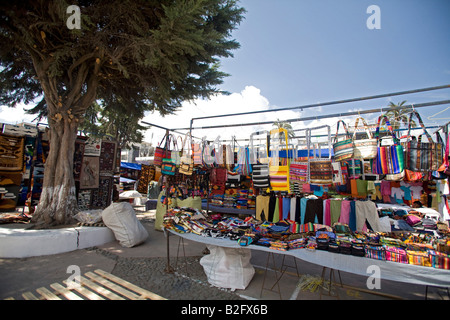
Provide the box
[166,230,450,287]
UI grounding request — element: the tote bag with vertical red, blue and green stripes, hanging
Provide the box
[373,115,405,174]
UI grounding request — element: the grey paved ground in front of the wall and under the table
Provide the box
[0,214,449,301]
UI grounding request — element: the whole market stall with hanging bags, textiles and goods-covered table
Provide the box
[146,88,450,296]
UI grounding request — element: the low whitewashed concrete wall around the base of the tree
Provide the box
[0,227,116,258]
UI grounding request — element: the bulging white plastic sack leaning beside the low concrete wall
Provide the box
[102,202,148,248]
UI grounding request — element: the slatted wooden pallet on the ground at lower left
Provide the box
[7,269,166,300]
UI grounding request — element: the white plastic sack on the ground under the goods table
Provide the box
[200,245,255,290]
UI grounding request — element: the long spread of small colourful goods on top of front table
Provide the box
[164,208,450,270]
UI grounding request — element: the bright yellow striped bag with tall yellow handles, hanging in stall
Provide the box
[269,128,290,192]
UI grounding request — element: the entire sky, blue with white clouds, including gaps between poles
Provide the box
[0,0,450,144]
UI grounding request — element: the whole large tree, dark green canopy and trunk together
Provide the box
[0,0,244,227]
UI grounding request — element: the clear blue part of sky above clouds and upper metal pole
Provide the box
[222,0,450,107]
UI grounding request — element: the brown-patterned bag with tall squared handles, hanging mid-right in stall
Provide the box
[306,125,333,184]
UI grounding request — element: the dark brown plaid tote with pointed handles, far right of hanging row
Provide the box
[405,110,442,172]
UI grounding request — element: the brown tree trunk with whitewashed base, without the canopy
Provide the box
[32,116,78,229]
